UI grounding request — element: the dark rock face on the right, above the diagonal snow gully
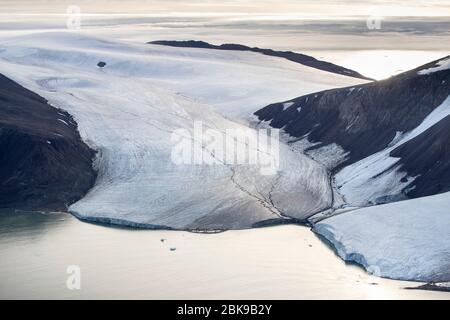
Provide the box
[255,57,450,167]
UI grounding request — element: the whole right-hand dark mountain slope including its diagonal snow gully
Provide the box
[256,56,450,205]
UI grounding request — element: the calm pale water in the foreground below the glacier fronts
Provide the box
[0,213,450,299]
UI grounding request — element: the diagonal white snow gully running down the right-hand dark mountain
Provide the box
[336,97,450,206]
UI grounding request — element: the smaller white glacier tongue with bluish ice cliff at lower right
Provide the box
[314,193,450,282]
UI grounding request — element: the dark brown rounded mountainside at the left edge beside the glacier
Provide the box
[0,75,96,211]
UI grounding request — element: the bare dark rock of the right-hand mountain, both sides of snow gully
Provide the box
[255,58,450,198]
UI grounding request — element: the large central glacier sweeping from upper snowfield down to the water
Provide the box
[0,32,360,230]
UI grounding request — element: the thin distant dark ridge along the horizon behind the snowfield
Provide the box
[149,40,373,80]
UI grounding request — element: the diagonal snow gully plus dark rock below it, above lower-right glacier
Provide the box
[336,96,450,206]
